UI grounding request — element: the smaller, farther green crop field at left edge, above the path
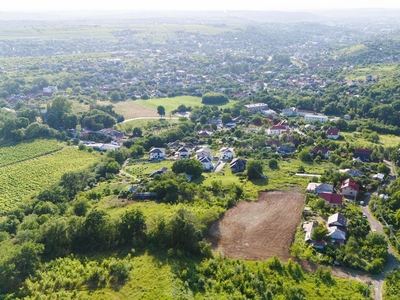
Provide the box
[0,139,63,167]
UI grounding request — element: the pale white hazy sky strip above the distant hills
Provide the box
[0,0,400,11]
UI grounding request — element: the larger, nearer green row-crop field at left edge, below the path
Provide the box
[0,148,98,214]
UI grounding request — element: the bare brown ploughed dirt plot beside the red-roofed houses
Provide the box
[207,191,305,261]
